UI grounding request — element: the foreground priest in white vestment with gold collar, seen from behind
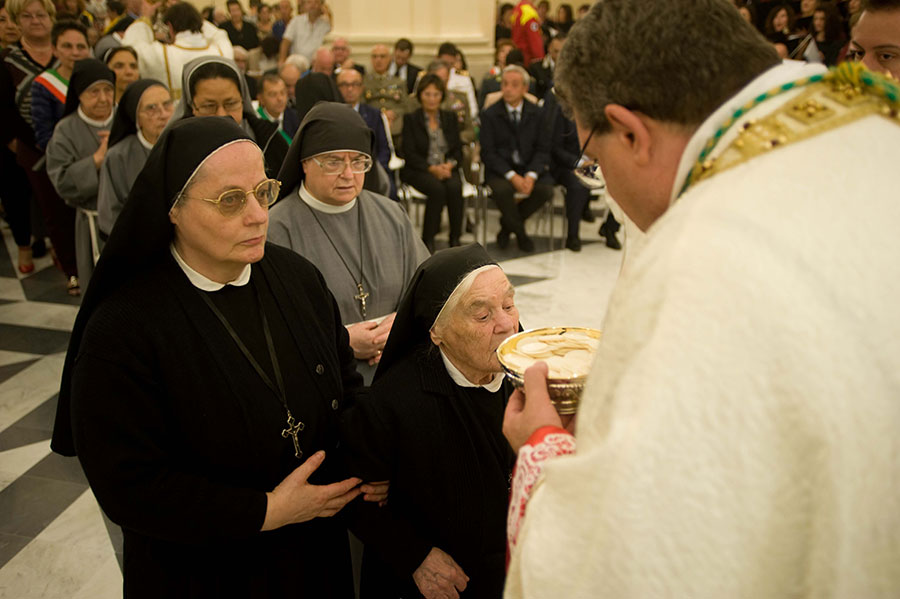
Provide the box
[504,0,900,599]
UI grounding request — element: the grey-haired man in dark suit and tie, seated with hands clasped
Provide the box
[481,65,553,252]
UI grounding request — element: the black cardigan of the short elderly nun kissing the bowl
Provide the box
[342,346,515,599]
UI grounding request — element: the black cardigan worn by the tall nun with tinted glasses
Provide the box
[72,244,362,598]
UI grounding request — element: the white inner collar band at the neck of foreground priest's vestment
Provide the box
[669,60,827,204]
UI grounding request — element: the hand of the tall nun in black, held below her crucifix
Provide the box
[262,451,362,530]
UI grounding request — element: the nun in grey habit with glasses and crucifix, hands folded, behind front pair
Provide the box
[269,102,429,384]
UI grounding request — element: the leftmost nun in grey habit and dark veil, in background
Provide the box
[47,58,116,292]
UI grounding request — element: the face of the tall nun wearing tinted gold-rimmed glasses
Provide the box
[169,142,269,283]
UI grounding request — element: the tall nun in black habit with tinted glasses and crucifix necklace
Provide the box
[52,117,383,599]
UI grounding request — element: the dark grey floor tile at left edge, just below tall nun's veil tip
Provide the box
[0,471,87,538]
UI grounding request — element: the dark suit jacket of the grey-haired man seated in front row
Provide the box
[481,100,550,180]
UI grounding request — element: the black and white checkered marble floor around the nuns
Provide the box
[0,205,622,599]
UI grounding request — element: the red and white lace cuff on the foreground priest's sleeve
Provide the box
[506,426,575,554]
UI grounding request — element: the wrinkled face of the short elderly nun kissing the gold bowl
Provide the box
[431,268,519,384]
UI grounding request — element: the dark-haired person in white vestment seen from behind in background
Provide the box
[122,2,234,100]
